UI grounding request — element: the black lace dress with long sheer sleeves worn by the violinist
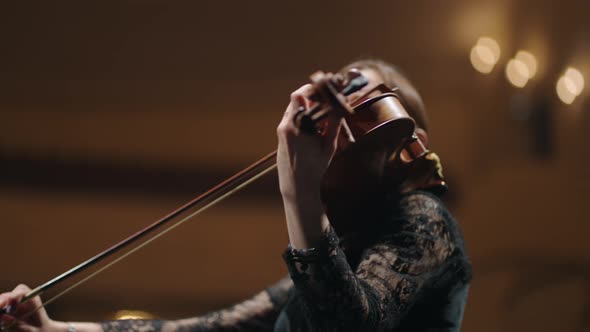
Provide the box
[101,191,471,332]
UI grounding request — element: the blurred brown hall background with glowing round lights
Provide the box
[0,0,590,331]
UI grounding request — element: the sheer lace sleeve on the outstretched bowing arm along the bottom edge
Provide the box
[101,277,293,332]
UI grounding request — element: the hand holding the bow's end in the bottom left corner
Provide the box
[0,284,61,332]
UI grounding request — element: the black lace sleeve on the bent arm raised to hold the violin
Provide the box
[284,191,454,331]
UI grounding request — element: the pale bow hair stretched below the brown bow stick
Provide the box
[5,163,277,331]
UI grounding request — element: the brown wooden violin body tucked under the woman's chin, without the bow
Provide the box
[302,73,446,234]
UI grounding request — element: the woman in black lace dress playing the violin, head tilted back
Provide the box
[0,60,471,332]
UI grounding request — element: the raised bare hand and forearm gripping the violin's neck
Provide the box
[277,84,342,248]
